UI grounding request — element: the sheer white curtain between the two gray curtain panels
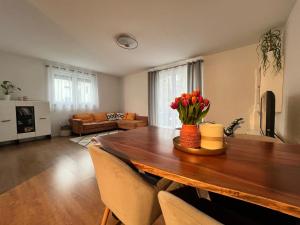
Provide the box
[156,65,188,128]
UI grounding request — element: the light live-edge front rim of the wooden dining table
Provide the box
[131,161,300,218]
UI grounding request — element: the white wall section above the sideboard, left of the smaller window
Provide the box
[0,51,47,100]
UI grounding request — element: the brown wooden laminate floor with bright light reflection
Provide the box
[0,138,163,225]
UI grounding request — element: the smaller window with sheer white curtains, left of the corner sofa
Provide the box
[48,67,98,112]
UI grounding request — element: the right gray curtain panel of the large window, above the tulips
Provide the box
[187,60,203,93]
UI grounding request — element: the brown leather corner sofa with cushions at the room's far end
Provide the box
[69,112,148,135]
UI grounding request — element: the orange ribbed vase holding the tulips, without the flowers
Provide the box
[180,124,200,148]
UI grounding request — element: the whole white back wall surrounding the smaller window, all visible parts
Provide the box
[0,51,122,135]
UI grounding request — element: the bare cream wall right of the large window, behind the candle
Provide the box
[203,45,258,132]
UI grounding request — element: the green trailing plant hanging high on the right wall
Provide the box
[257,29,282,72]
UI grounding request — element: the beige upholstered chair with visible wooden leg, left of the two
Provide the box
[89,145,170,225]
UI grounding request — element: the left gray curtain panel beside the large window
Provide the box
[148,71,158,126]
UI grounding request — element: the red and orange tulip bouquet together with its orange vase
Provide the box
[171,91,210,148]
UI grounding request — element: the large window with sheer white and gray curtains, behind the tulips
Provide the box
[148,58,203,128]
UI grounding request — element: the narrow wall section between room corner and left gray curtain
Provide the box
[122,71,148,116]
